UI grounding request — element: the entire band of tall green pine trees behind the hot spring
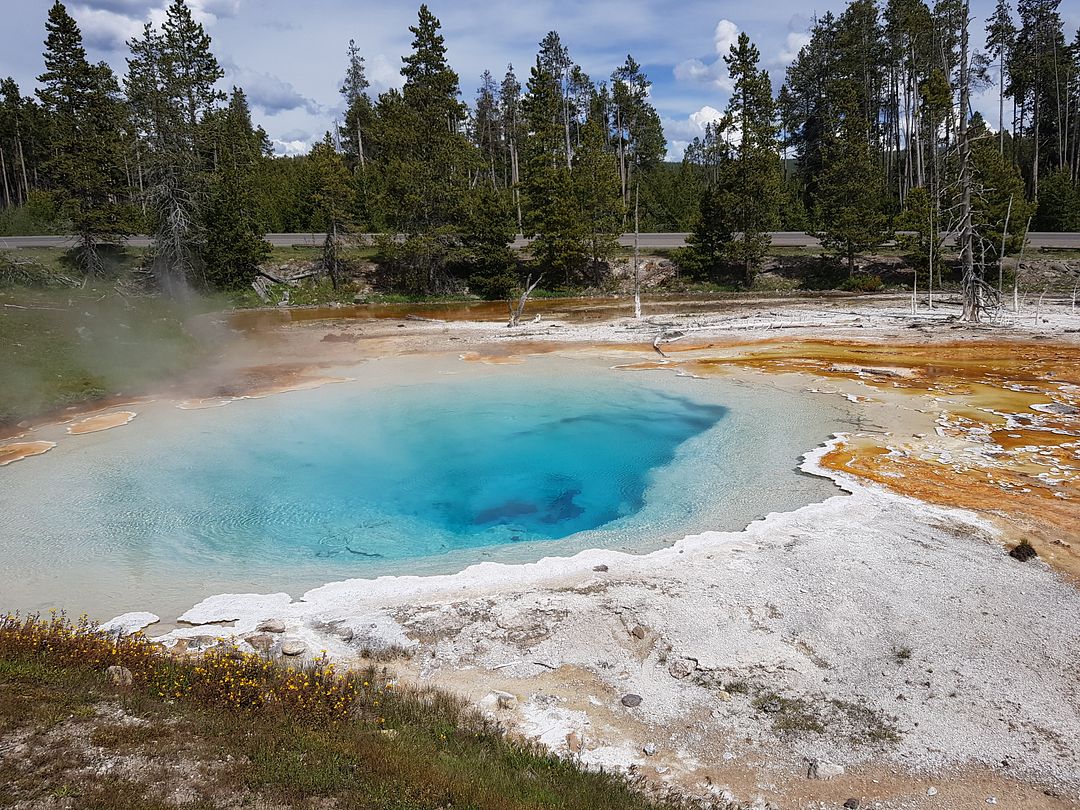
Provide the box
[0,0,1080,295]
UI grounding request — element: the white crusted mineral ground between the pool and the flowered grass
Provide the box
[154,449,1080,796]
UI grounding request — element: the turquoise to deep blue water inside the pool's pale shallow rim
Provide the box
[103,376,726,563]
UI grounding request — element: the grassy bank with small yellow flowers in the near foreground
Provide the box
[0,616,670,810]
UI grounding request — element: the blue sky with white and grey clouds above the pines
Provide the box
[0,0,1080,159]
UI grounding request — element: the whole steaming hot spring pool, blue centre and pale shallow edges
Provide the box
[0,357,841,619]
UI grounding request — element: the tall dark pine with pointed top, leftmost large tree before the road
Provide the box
[38,0,131,274]
